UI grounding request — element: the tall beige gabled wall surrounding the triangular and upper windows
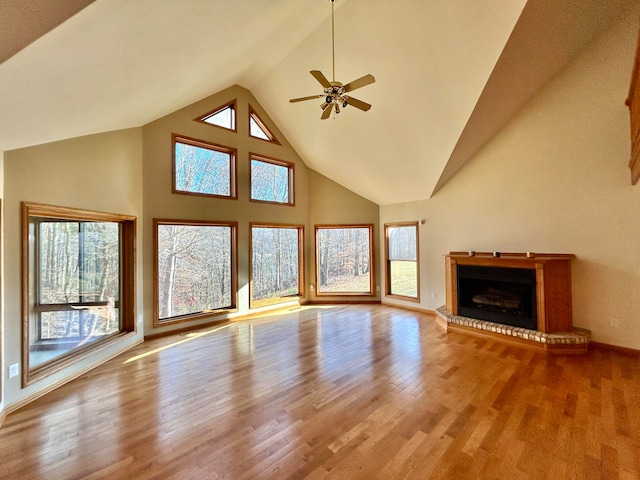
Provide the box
[143,86,378,335]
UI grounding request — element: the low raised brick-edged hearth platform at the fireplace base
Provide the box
[436,306,591,355]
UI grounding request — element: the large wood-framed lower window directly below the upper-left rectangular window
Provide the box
[154,220,238,326]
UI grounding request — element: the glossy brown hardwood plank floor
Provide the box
[0,305,640,480]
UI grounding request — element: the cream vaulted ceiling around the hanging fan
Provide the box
[0,0,638,205]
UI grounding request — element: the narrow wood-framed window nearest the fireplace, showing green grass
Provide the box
[384,222,420,301]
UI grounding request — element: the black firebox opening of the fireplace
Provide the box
[457,265,538,330]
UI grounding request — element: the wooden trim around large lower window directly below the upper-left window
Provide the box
[153,218,238,328]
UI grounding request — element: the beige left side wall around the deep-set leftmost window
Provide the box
[3,129,144,406]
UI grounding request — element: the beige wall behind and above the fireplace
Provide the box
[381,11,640,349]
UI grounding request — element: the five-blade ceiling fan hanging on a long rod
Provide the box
[289,0,376,120]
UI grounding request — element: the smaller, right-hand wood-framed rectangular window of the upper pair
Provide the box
[251,154,294,205]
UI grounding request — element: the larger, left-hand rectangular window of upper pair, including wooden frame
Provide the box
[173,135,236,198]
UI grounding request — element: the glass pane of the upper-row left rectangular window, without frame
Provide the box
[174,141,233,197]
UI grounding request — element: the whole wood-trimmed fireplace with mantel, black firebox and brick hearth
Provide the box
[436,252,590,353]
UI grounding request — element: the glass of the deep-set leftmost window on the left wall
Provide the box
[29,219,121,367]
